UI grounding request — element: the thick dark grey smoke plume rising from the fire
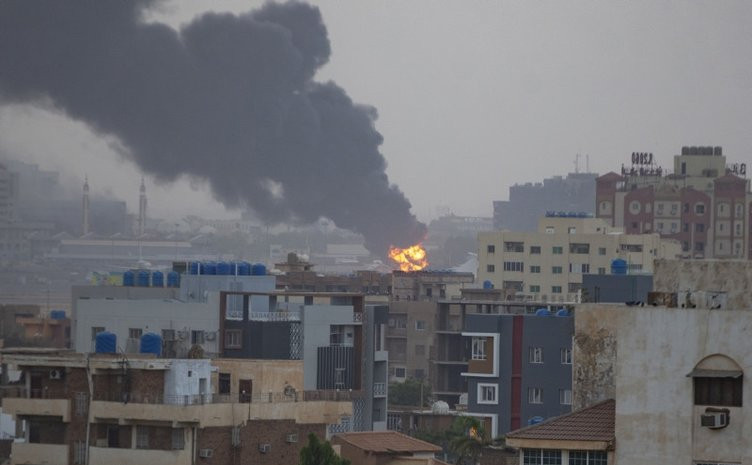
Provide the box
[0,0,425,254]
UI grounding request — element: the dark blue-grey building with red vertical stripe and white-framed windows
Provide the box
[462,310,574,437]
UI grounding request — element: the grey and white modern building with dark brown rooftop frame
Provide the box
[218,291,388,433]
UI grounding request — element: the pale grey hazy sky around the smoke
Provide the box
[0,0,752,220]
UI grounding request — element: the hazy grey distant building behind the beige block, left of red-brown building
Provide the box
[493,173,598,232]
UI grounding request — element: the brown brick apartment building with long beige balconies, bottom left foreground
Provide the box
[1,349,352,465]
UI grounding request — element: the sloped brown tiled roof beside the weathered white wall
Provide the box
[506,399,616,445]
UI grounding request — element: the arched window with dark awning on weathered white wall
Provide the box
[687,354,744,407]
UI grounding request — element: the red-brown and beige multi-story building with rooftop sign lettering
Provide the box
[596,147,752,259]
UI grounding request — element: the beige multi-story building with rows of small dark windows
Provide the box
[478,216,681,302]
